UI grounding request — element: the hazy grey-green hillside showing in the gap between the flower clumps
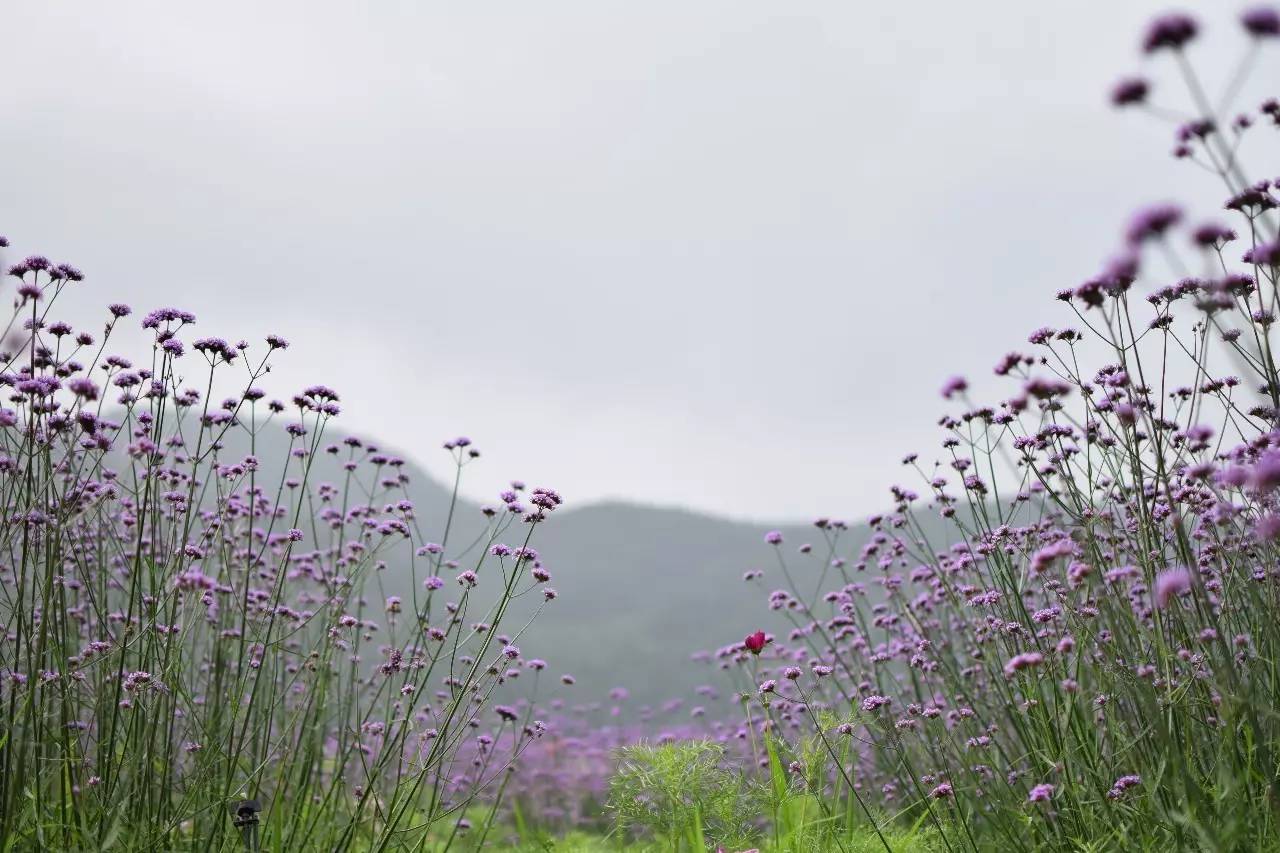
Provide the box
[499,503,819,702]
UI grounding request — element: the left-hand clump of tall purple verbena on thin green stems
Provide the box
[0,249,561,850]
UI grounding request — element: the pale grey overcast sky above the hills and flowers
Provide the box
[0,0,1280,519]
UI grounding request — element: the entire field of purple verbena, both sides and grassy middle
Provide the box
[0,6,1280,852]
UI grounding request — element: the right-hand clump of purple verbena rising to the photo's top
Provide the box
[722,9,1280,850]
